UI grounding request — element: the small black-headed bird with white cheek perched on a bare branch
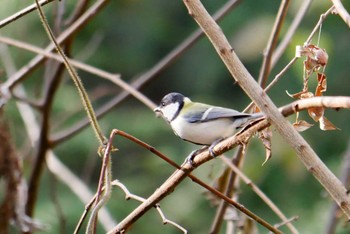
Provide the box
[154,93,264,164]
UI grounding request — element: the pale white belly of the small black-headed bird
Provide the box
[171,118,236,145]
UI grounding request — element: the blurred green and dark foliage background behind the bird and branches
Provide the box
[0,0,350,233]
